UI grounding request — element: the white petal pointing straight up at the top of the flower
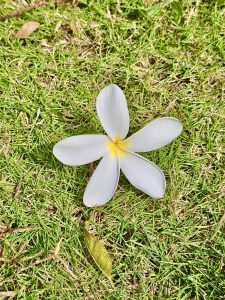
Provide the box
[96,84,129,139]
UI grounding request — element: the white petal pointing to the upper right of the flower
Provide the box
[127,118,183,152]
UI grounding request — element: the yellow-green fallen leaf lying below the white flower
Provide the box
[84,221,112,279]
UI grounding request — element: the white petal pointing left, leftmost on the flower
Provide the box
[53,134,109,166]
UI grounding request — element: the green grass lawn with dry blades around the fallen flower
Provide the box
[0,0,225,300]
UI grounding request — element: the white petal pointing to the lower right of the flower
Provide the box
[119,152,166,198]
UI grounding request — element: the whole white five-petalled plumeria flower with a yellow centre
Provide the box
[53,84,183,207]
